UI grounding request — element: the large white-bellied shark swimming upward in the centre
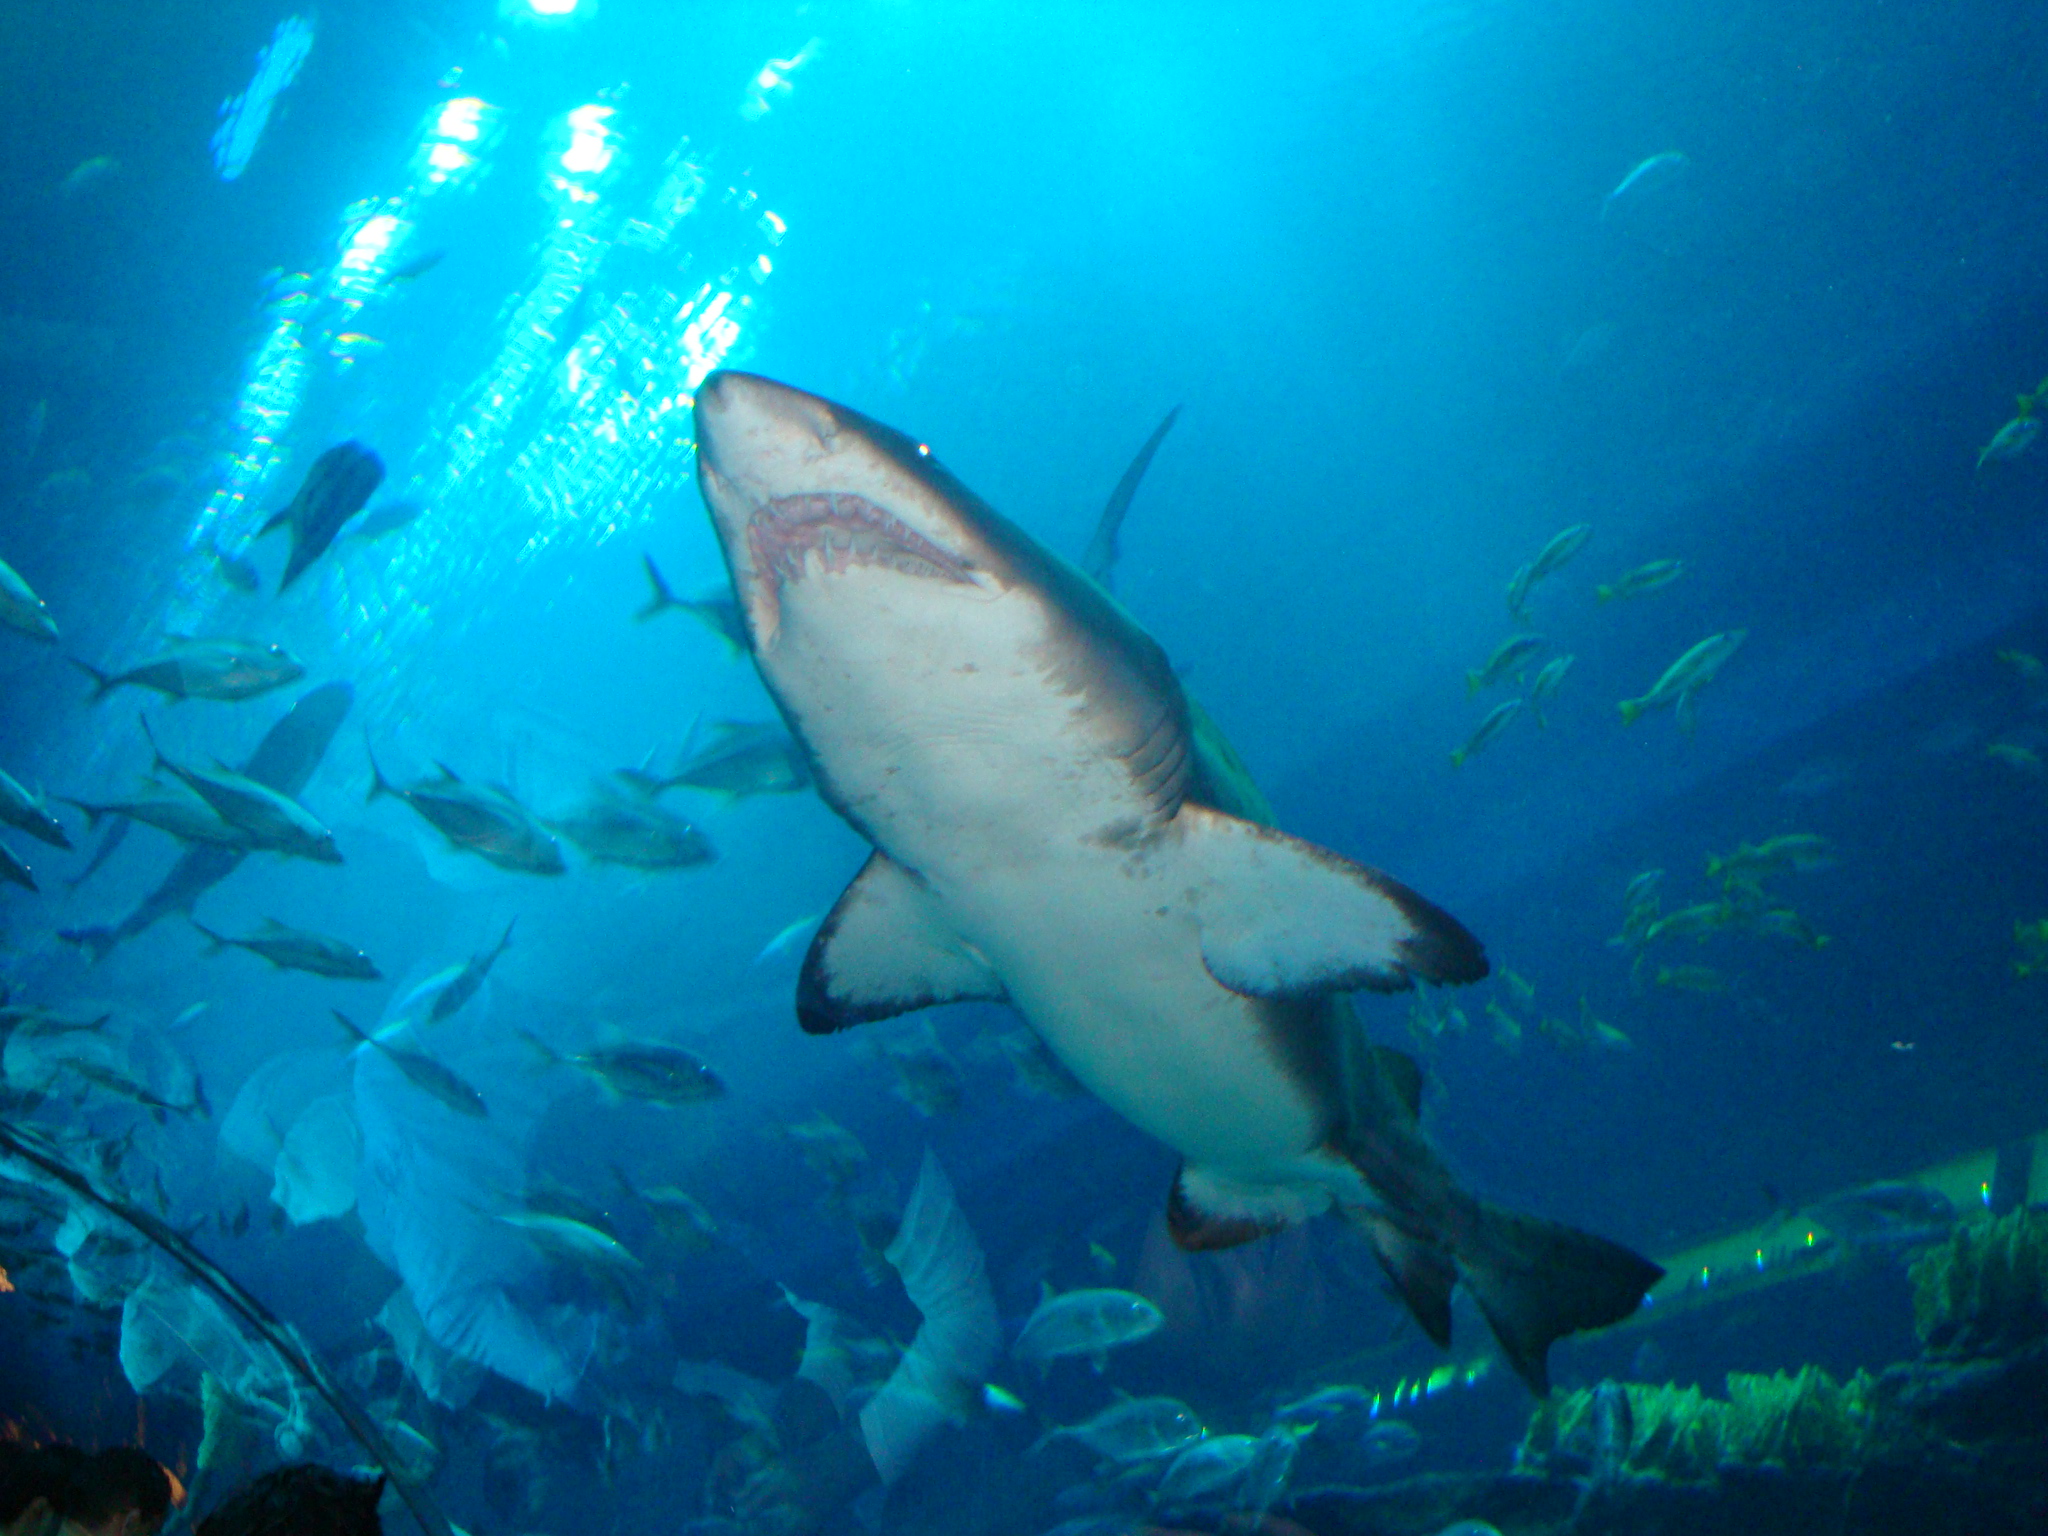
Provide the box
[694,371,1663,1395]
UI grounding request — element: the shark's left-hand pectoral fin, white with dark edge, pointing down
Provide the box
[797,852,1006,1034]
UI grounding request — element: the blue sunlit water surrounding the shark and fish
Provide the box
[0,0,2048,1532]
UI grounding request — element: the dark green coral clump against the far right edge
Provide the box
[1909,1210,2048,1356]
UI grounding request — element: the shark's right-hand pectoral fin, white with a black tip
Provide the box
[1176,803,1487,997]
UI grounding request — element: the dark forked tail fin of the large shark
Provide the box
[1458,1202,1663,1397]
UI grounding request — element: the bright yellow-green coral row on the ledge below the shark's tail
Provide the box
[1522,1366,1872,1483]
